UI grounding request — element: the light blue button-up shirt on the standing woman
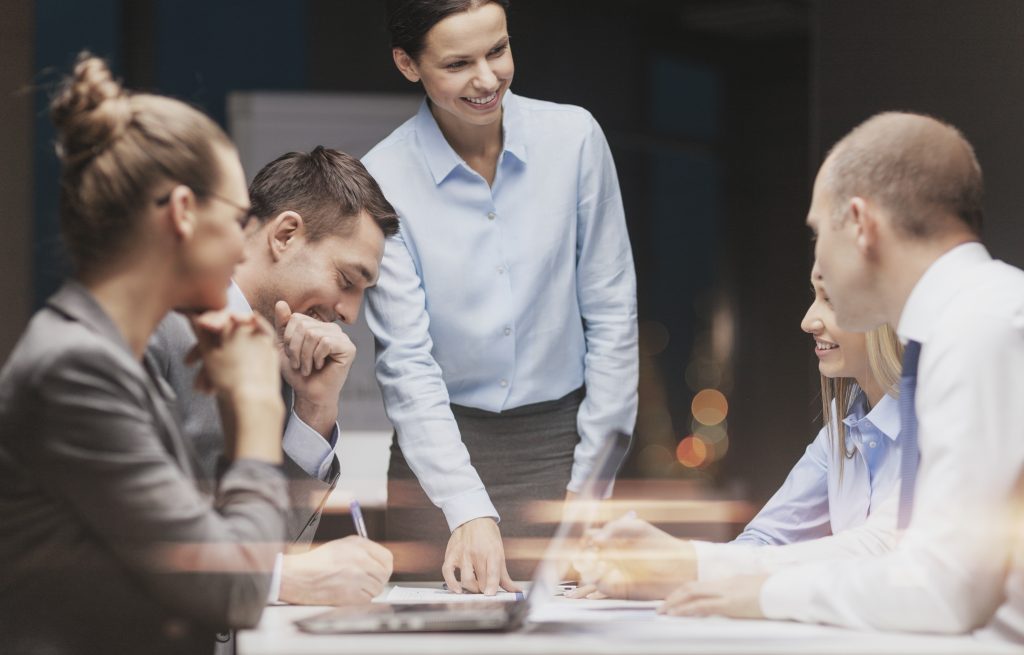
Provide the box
[362,92,638,529]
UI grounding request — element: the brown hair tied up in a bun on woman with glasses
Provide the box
[50,52,231,274]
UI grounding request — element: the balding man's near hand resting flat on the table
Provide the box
[657,575,768,618]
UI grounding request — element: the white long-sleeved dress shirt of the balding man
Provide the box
[761,244,1024,632]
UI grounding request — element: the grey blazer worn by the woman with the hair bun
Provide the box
[0,281,288,653]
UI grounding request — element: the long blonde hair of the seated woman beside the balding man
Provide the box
[821,324,903,480]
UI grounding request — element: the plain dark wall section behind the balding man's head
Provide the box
[814,0,1024,266]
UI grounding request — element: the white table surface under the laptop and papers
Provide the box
[238,599,1021,655]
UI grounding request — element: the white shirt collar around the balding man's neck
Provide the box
[896,242,992,344]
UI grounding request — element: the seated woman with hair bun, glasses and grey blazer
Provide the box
[0,54,288,653]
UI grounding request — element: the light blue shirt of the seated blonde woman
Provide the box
[734,392,900,545]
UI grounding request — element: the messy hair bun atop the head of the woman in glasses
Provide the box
[50,52,132,165]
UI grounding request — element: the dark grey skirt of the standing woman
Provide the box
[385,388,585,580]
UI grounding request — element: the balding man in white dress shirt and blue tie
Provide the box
[643,113,1024,643]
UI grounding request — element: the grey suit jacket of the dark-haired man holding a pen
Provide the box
[146,312,340,544]
